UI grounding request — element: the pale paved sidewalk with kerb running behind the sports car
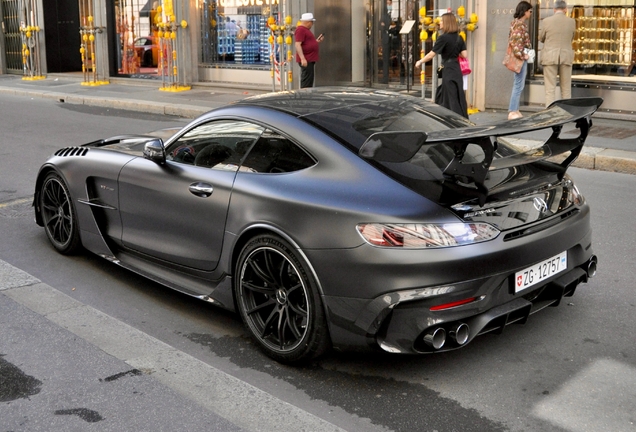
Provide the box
[0,74,636,174]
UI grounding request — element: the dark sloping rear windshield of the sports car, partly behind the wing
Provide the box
[305,98,517,204]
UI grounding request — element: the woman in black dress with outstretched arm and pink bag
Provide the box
[415,13,468,118]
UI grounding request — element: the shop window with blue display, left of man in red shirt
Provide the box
[201,0,279,66]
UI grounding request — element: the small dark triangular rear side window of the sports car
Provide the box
[241,130,316,173]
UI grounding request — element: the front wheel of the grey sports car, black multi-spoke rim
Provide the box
[39,172,82,255]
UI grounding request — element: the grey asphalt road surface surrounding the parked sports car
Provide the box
[0,96,636,432]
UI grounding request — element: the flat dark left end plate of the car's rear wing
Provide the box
[358,131,427,162]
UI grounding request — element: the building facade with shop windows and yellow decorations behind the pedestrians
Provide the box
[0,0,636,114]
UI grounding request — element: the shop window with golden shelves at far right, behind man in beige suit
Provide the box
[537,0,636,78]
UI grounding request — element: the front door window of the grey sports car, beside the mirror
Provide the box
[166,120,264,171]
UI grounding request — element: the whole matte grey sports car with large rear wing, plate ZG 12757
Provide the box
[34,88,602,363]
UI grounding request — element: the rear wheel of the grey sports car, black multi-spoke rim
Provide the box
[234,234,331,363]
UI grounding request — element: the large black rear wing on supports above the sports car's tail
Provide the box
[359,97,603,204]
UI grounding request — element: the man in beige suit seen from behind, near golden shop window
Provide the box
[539,0,576,107]
